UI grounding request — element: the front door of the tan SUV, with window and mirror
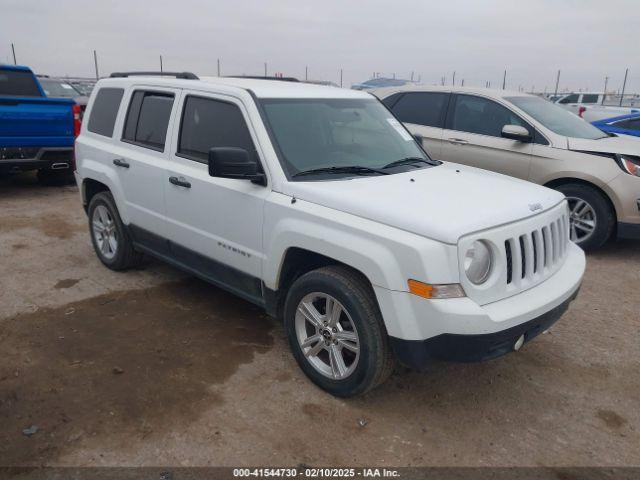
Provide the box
[442,94,535,180]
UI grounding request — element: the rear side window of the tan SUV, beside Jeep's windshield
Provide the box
[392,92,449,128]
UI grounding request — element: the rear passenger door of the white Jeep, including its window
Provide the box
[109,86,179,243]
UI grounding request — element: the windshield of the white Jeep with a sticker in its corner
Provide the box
[261,99,429,180]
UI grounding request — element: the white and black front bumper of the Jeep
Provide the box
[374,243,586,368]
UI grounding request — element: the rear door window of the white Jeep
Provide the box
[122,91,173,152]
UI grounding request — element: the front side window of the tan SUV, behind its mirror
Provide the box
[447,95,532,137]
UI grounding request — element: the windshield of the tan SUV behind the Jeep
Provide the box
[505,97,607,140]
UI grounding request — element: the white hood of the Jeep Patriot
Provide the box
[282,162,564,244]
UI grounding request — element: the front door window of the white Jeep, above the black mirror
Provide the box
[178,96,255,163]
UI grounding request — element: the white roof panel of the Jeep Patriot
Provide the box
[100,75,371,99]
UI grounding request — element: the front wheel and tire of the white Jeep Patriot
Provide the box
[284,266,395,397]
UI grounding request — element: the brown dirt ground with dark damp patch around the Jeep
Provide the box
[0,172,640,466]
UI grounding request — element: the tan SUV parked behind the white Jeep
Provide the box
[372,86,640,248]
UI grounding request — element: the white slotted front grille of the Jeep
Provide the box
[504,215,569,285]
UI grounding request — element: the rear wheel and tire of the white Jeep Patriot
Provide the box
[88,192,142,271]
